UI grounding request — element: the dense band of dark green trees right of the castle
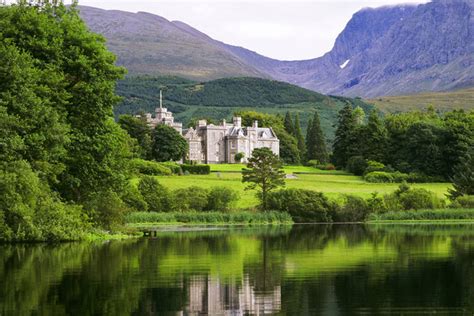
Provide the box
[332,106,474,181]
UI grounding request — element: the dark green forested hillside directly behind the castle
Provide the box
[115,76,372,139]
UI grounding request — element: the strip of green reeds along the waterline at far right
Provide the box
[369,209,474,222]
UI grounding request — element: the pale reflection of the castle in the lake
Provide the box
[185,276,281,315]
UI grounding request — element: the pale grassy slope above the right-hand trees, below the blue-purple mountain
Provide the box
[368,88,474,113]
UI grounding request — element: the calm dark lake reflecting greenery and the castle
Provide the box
[0,225,474,315]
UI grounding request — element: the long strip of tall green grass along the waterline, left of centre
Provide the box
[125,212,293,227]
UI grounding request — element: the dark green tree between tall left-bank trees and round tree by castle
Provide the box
[118,115,152,159]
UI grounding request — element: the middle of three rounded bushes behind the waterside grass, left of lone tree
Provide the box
[173,186,209,212]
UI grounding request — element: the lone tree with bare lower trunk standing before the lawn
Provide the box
[242,148,285,210]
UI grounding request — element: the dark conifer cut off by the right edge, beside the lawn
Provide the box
[448,149,474,200]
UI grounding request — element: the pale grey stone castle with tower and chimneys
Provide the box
[146,91,280,164]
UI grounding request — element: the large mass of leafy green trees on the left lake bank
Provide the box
[0,0,139,241]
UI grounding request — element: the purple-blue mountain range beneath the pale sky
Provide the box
[80,0,474,97]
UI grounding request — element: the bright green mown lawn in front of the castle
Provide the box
[151,165,451,208]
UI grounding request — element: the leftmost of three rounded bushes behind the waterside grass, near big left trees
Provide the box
[138,176,172,212]
